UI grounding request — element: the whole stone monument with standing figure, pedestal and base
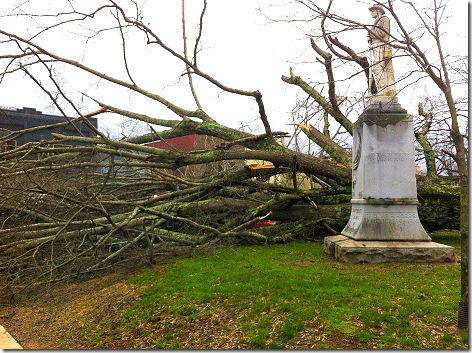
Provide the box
[324,5,455,263]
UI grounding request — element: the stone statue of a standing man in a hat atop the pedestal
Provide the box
[367,5,396,97]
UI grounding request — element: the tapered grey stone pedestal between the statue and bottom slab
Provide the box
[341,97,431,241]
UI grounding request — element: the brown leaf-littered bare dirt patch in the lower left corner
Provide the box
[0,274,144,349]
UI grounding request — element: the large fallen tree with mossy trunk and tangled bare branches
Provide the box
[0,1,464,294]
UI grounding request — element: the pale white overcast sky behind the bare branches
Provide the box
[0,0,468,139]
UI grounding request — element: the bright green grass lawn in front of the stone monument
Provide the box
[83,230,468,349]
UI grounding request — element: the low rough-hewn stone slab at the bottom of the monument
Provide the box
[324,235,456,264]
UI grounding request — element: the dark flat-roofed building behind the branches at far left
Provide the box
[0,106,97,151]
